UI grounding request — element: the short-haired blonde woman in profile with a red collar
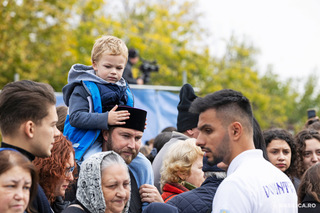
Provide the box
[161,138,204,203]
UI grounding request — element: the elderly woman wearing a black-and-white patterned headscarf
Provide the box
[63,151,130,213]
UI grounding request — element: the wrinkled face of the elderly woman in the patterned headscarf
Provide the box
[101,164,130,213]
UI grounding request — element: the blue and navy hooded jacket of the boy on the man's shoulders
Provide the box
[62,64,133,163]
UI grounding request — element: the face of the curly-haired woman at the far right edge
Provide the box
[303,138,320,170]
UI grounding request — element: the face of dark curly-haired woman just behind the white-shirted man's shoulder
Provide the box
[267,139,291,172]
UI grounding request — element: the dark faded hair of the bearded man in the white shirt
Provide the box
[190,89,253,132]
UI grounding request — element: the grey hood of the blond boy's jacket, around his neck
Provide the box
[62,64,127,106]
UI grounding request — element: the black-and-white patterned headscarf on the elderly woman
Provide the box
[76,151,130,213]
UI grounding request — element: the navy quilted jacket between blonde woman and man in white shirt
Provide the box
[167,175,223,213]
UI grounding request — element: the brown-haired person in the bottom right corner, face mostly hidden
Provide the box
[298,163,320,213]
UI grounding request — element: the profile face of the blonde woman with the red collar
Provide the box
[186,155,204,187]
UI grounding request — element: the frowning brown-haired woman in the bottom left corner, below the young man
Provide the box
[0,148,38,213]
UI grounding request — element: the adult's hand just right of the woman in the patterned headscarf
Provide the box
[139,184,164,203]
